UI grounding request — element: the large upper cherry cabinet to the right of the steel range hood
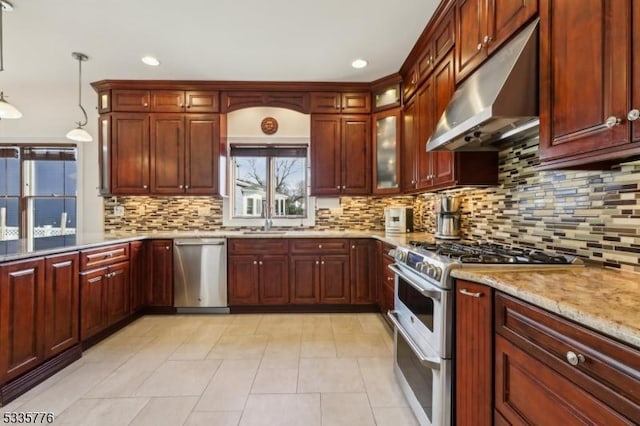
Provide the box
[540,0,640,169]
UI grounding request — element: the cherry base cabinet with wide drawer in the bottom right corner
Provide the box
[495,292,640,424]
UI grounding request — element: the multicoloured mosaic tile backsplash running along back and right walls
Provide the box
[104,139,640,272]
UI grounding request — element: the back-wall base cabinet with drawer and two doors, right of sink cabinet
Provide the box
[289,238,351,304]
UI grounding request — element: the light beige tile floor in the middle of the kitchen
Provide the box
[0,314,417,426]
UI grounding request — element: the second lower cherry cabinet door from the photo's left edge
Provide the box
[44,253,80,358]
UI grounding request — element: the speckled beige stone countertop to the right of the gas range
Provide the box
[451,267,640,348]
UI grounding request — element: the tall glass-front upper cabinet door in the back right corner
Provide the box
[373,108,400,194]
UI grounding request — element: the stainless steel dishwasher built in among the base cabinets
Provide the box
[173,238,229,313]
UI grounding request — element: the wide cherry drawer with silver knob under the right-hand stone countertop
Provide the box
[495,293,640,422]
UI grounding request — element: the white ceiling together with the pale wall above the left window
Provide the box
[0,0,439,142]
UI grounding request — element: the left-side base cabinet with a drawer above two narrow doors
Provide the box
[80,243,131,340]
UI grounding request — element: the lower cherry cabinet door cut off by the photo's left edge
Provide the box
[0,259,45,383]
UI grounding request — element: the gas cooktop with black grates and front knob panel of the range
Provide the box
[390,241,584,289]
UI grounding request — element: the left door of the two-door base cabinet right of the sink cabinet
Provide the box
[289,255,320,304]
